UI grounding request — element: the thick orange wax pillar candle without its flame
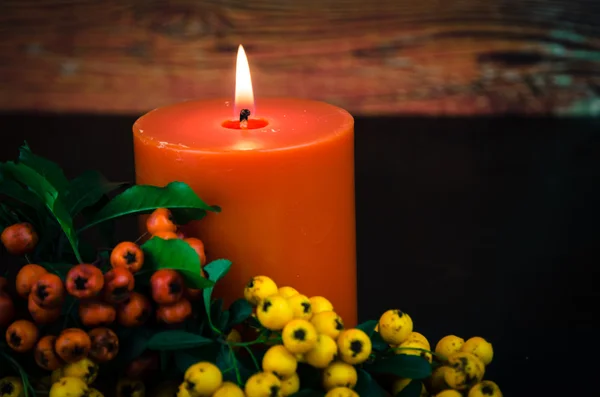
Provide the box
[133,98,357,326]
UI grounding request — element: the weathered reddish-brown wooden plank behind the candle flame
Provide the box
[0,0,600,116]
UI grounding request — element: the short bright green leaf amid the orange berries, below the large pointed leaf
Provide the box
[141,237,214,288]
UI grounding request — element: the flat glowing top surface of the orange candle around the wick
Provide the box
[133,98,354,152]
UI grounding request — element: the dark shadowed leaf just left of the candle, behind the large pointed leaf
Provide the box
[64,171,126,216]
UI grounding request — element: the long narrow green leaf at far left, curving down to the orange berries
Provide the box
[2,161,82,263]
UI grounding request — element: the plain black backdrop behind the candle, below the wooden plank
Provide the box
[0,113,600,396]
